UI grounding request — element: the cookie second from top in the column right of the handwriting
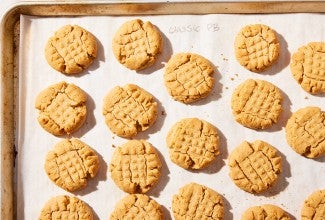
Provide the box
[231,79,282,130]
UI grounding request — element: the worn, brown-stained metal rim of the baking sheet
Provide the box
[0,0,325,220]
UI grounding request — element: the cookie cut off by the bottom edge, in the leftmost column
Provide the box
[39,196,94,220]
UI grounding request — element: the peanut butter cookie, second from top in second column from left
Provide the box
[103,84,158,138]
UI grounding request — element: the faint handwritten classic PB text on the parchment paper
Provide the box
[168,23,220,34]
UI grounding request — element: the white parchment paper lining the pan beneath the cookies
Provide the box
[16,14,325,219]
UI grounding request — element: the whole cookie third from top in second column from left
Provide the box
[110,140,162,193]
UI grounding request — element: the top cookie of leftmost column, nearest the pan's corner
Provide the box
[45,25,97,74]
